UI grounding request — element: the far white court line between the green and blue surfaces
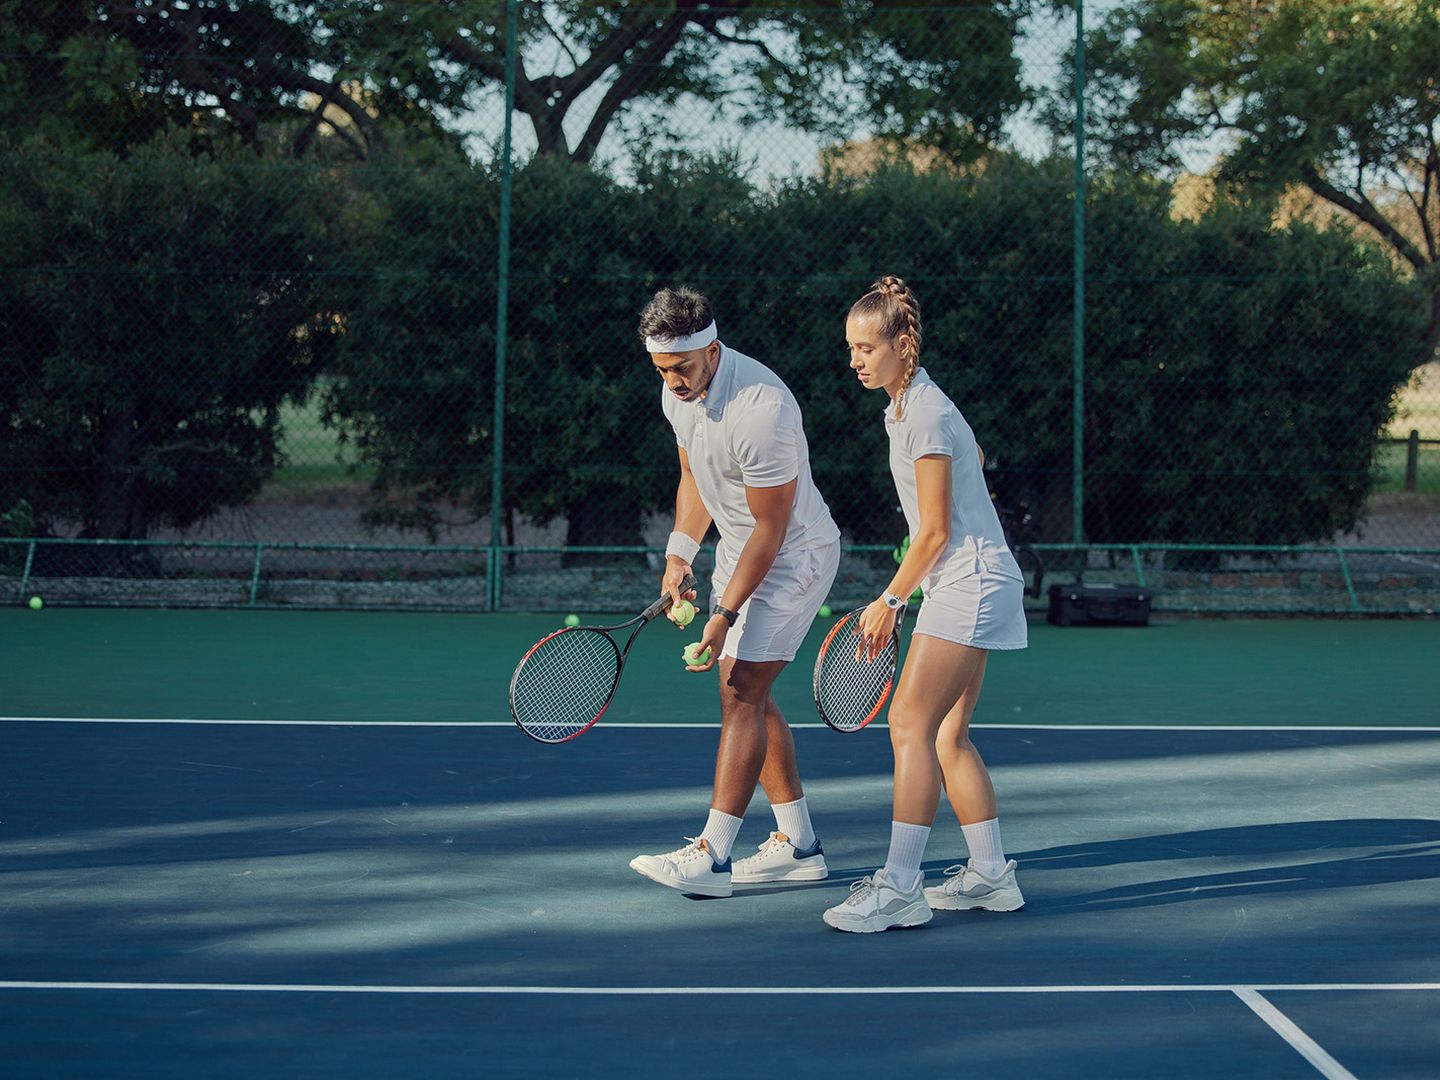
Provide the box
[0,716,1440,734]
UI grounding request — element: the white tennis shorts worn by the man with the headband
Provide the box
[710,540,840,661]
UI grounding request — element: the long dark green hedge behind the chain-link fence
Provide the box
[0,140,1418,544]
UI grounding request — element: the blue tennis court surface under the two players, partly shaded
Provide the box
[0,702,1440,1077]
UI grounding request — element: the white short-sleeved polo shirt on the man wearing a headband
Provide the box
[660,344,840,576]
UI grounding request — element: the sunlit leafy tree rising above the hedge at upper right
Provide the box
[1086,0,1440,366]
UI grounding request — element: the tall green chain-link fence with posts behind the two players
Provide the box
[0,0,1440,611]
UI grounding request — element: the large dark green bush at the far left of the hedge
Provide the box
[0,140,328,540]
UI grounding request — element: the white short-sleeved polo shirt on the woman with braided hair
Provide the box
[886,367,1024,592]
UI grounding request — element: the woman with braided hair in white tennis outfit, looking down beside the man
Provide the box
[825,276,1027,933]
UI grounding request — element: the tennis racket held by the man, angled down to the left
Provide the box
[510,576,696,743]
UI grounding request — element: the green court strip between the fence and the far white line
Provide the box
[0,608,1440,726]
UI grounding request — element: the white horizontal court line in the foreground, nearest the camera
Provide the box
[0,979,1440,996]
